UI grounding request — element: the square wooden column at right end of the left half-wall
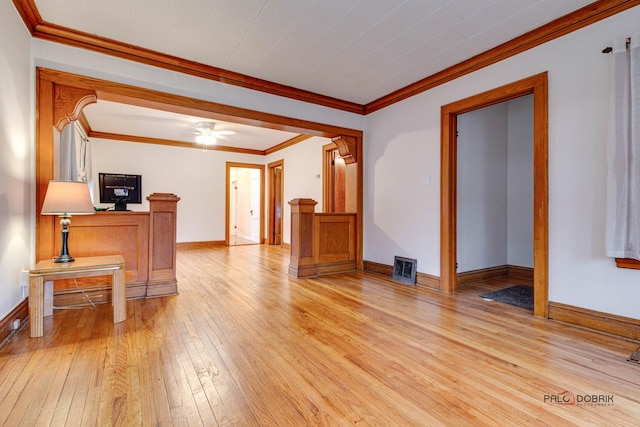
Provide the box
[147,193,180,297]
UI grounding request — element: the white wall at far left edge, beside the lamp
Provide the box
[0,2,35,319]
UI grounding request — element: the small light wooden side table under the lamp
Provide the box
[29,255,127,338]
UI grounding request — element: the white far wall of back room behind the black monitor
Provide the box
[91,138,263,242]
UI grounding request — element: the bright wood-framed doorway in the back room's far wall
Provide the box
[225,162,264,246]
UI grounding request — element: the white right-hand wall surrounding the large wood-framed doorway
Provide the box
[365,7,640,318]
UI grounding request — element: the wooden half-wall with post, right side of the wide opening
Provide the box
[289,199,357,277]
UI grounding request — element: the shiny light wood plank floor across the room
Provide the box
[0,246,640,426]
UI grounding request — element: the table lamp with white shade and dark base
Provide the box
[42,181,95,262]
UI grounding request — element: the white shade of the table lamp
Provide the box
[42,181,95,215]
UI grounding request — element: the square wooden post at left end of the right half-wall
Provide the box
[289,199,318,277]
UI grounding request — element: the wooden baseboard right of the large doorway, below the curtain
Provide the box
[549,302,640,340]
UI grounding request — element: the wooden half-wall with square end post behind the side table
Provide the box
[52,193,180,305]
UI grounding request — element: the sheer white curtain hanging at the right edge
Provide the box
[606,33,640,260]
